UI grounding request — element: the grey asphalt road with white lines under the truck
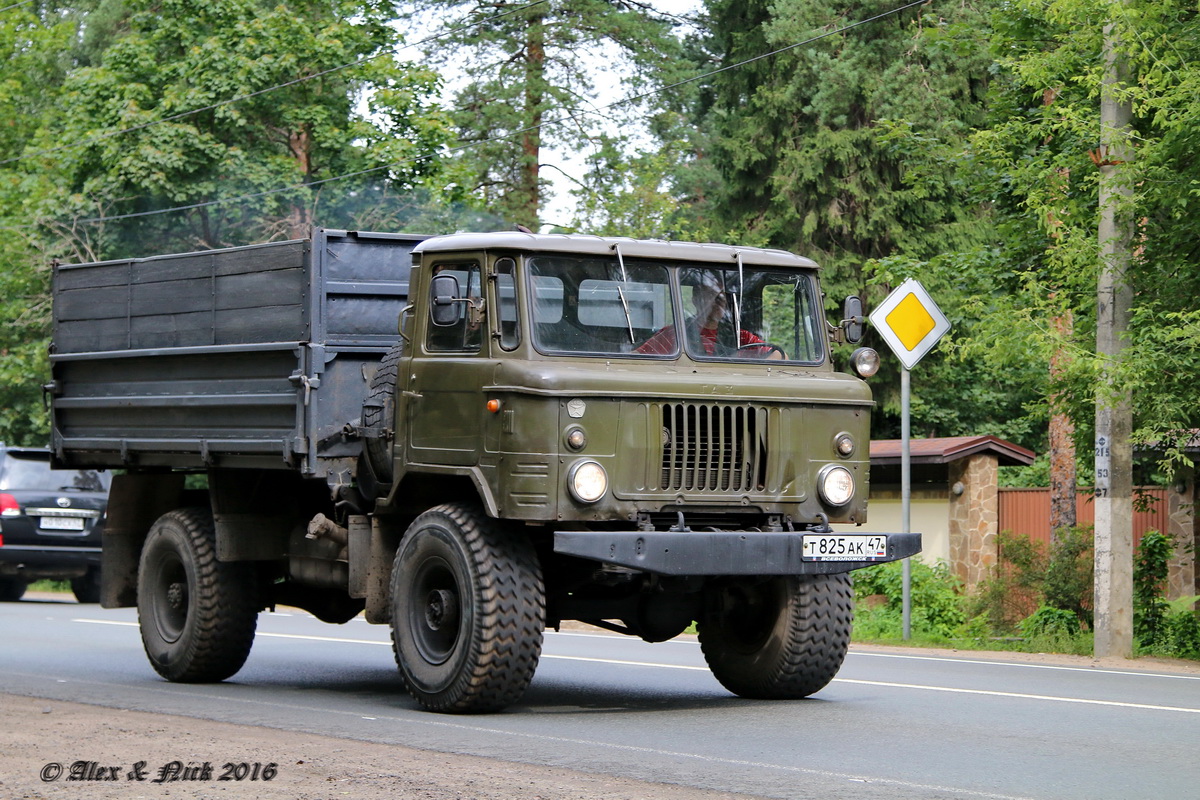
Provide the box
[0,600,1200,800]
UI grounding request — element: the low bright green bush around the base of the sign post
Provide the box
[854,560,966,639]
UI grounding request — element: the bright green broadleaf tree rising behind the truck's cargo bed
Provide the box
[41,0,448,255]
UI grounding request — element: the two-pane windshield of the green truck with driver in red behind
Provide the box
[529,255,824,363]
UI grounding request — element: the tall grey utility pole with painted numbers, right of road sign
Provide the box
[1093,23,1134,658]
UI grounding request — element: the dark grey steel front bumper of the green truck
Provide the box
[554,530,920,576]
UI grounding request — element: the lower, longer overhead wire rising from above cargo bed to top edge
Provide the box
[39,0,932,230]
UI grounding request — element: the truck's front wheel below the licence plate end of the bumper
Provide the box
[697,573,854,699]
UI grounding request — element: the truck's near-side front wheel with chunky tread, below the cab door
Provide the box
[391,504,546,714]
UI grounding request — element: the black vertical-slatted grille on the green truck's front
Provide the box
[658,403,767,492]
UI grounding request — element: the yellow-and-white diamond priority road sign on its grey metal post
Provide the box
[869,278,950,640]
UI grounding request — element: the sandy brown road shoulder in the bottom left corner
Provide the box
[0,694,768,800]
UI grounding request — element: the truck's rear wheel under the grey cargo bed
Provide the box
[138,509,259,684]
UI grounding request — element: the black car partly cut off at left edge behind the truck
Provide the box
[0,444,112,603]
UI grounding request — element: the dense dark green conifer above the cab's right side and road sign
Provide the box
[704,0,988,284]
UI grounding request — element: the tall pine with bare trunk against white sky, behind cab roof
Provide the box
[408,0,679,229]
